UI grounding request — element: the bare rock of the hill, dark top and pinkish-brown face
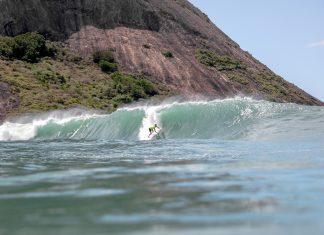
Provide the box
[0,0,323,121]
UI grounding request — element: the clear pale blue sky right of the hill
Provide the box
[189,0,324,101]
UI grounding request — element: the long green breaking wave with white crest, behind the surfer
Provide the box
[0,98,324,141]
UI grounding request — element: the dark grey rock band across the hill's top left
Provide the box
[0,0,164,40]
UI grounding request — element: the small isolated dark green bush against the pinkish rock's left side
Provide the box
[93,51,118,74]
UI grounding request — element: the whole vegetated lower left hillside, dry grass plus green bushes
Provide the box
[0,37,163,115]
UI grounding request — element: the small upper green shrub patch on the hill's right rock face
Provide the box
[195,49,246,71]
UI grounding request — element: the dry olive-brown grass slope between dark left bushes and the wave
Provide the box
[0,43,167,118]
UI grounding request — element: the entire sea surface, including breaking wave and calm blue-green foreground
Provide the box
[0,99,324,235]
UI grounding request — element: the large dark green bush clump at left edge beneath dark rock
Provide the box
[0,32,55,63]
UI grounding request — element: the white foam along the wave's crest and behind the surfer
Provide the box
[0,97,294,141]
